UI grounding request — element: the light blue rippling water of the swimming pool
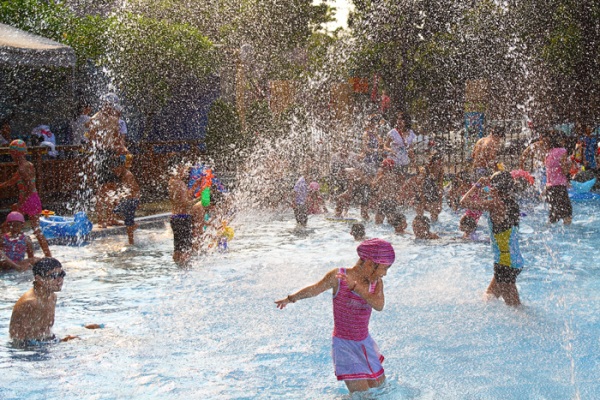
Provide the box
[0,203,600,399]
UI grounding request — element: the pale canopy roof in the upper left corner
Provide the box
[0,24,76,67]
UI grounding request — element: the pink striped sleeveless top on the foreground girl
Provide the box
[333,268,377,341]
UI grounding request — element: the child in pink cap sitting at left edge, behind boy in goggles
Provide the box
[0,211,37,271]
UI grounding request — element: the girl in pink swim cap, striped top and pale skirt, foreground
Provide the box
[275,239,396,392]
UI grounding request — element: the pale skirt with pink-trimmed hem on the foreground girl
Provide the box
[332,335,383,381]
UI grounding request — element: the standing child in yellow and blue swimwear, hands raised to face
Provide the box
[460,171,524,307]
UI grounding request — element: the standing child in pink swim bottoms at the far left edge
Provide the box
[0,139,52,257]
